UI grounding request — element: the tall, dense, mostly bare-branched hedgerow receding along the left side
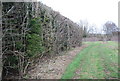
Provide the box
[2,2,82,77]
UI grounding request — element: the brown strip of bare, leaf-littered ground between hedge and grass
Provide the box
[28,45,87,79]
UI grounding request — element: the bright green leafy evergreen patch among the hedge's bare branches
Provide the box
[26,18,44,57]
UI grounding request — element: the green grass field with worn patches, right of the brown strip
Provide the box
[62,41,118,79]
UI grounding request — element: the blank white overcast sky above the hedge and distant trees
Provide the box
[39,0,119,32]
